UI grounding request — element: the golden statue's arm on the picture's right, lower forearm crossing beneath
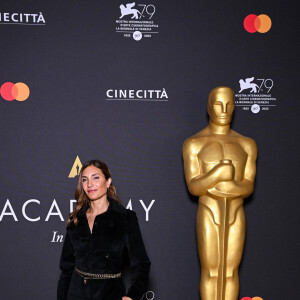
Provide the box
[215,139,257,198]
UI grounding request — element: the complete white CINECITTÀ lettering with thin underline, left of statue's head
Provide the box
[106,88,169,102]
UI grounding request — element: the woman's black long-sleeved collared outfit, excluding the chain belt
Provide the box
[57,199,150,300]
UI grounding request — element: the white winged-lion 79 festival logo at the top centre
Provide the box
[116,2,158,41]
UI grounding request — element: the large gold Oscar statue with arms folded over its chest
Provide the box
[183,87,257,300]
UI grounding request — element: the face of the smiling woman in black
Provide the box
[82,166,111,201]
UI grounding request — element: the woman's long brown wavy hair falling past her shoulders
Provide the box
[68,159,121,226]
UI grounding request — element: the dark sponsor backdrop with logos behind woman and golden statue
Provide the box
[0,0,300,300]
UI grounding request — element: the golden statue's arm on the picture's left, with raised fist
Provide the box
[183,139,234,197]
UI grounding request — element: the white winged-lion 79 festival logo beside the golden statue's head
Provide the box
[235,77,277,114]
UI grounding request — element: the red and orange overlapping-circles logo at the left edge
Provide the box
[0,82,30,101]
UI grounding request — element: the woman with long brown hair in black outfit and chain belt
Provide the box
[57,160,150,300]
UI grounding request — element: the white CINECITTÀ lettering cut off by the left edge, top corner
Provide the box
[0,12,46,25]
